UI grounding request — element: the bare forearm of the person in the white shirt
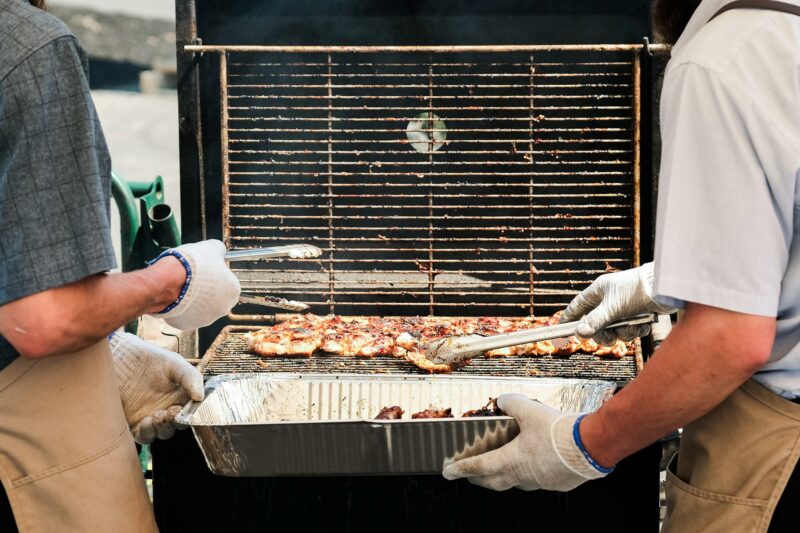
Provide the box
[580,305,775,466]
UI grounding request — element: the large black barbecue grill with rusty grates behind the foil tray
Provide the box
[154,2,659,531]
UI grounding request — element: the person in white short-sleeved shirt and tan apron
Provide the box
[444,0,800,533]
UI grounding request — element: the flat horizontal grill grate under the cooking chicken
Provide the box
[199,326,642,383]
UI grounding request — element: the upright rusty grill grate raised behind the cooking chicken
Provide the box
[200,46,640,318]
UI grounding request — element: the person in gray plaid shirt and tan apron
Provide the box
[0,0,239,532]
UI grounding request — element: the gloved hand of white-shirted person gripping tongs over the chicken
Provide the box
[561,263,676,346]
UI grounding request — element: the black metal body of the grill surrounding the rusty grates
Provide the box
[152,0,661,532]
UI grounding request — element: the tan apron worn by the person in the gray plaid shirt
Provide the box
[0,340,157,533]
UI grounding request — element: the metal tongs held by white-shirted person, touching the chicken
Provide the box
[425,314,657,365]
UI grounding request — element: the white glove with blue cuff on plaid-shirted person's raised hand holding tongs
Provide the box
[151,239,240,330]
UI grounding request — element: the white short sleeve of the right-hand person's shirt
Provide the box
[654,63,797,316]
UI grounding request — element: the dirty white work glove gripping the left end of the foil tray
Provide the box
[109,333,203,444]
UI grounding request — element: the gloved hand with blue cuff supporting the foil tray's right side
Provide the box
[443,394,612,491]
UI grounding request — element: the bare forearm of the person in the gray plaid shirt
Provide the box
[0,257,186,357]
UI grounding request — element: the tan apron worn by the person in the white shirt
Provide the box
[661,379,800,533]
